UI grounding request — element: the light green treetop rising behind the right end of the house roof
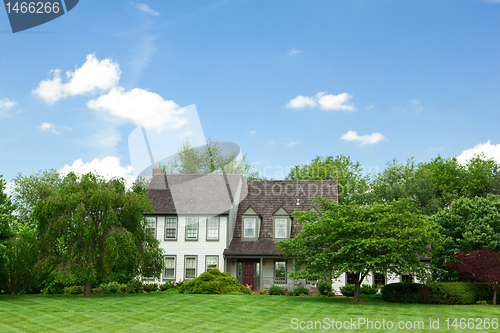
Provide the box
[286,155,370,204]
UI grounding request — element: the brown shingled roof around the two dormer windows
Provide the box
[224,180,338,256]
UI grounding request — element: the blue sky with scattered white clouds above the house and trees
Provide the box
[0,0,500,188]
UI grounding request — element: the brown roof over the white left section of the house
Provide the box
[148,174,243,214]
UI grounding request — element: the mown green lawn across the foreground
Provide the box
[0,293,500,333]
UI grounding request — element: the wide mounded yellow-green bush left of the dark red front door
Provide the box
[179,269,252,295]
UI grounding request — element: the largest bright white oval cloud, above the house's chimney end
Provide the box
[87,87,187,130]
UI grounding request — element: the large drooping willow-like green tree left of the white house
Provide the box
[33,173,163,295]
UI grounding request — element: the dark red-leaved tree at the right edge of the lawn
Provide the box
[448,248,500,305]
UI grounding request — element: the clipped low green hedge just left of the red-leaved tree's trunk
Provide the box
[431,282,476,305]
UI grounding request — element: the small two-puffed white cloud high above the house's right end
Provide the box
[286,92,356,112]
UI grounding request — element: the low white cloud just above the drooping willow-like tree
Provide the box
[59,156,135,187]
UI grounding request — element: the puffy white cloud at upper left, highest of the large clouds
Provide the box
[32,54,121,104]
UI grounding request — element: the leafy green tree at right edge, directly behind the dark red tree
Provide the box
[432,194,500,281]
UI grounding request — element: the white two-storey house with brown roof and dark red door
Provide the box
[146,169,424,290]
